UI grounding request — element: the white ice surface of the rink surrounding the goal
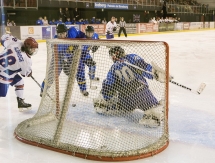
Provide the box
[0,30,215,163]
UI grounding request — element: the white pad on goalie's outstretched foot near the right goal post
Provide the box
[139,105,164,128]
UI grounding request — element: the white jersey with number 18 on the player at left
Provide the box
[0,43,32,84]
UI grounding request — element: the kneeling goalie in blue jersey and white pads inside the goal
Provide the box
[93,46,165,127]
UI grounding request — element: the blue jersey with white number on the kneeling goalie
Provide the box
[101,54,158,110]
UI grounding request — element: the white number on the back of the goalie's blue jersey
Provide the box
[115,66,135,82]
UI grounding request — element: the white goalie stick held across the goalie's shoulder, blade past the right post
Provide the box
[123,61,206,94]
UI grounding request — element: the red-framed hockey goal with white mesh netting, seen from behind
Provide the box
[15,39,168,160]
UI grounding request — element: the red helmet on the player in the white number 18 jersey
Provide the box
[22,37,38,56]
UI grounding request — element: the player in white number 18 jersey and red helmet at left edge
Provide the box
[0,34,38,111]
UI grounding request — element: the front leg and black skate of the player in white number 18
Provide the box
[10,74,31,112]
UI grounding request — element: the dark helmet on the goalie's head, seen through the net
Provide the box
[109,46,125,61]
